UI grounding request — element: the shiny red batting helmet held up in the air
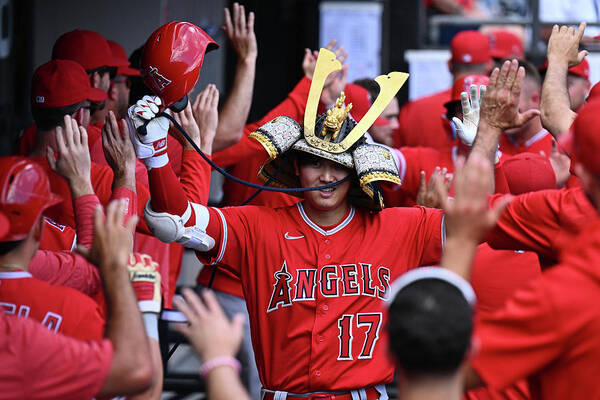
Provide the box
[142,21,219,107]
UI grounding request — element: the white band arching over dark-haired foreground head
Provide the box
[386,267,477,307]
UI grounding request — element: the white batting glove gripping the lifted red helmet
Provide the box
[127,96,169,169]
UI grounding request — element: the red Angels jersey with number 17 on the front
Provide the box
[200,203,444,393]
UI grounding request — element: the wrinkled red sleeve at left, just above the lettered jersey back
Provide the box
[29,250,102,295]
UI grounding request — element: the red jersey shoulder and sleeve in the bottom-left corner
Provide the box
[0,308,113,399]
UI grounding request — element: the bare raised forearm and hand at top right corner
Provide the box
[540,22,588,138]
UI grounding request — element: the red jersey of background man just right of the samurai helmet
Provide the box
[394,88,457,149]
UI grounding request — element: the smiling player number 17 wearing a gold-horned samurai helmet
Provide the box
[123,49,510,399]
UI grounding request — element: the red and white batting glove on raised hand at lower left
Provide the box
[127,253,161,313]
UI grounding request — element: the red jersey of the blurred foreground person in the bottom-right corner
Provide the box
[472,217,600,399]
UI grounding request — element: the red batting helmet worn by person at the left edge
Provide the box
[0,156,62,242]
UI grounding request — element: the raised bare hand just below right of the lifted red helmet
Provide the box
[192,84,219,154]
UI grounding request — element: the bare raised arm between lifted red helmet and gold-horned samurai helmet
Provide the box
[213,3,258,151]
